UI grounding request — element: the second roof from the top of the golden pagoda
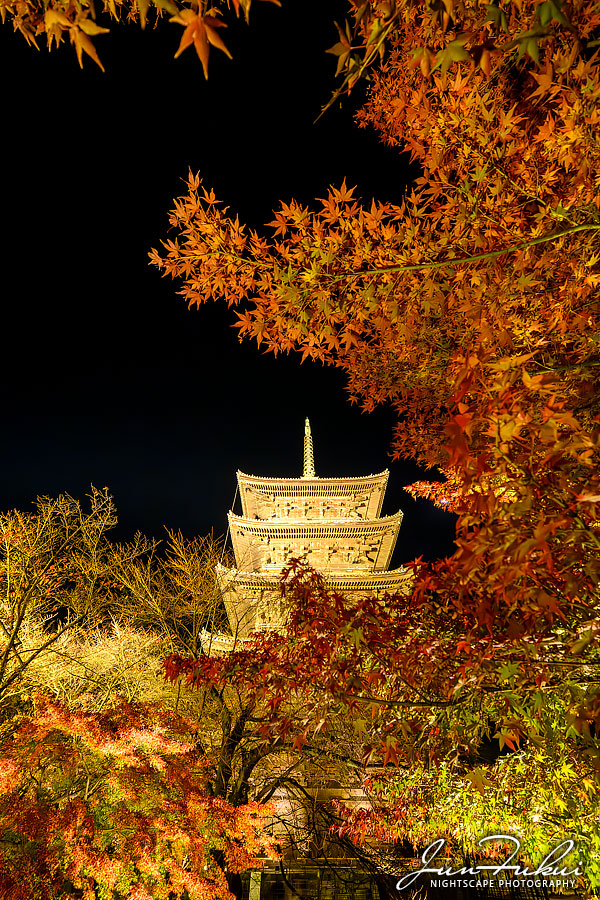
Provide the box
[228,511,403,572]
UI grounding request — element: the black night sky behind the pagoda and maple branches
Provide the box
[0,0,452,563]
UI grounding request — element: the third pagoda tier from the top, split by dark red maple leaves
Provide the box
[214,565,413,649]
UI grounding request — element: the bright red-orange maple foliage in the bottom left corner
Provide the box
[0,697,274,900]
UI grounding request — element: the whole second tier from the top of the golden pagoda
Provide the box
[229,512,402,574]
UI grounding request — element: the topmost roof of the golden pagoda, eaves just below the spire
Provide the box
[237,469,390,519]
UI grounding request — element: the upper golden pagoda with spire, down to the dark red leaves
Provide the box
[211,419,412,651]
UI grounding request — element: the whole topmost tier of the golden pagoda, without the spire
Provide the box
[237,469,389,519]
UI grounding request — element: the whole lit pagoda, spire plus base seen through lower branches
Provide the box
[202,419,412,900]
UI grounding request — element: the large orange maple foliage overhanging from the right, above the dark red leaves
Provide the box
[152,0,600,702]
